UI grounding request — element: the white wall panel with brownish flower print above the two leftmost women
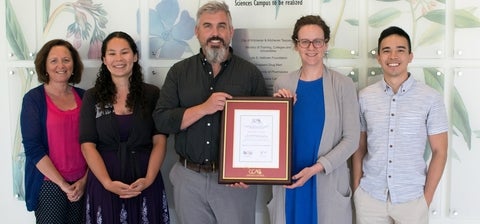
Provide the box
[41,0,140,59]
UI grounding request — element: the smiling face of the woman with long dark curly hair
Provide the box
[103,37,138,77]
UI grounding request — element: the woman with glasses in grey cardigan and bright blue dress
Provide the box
[268,15,360,224]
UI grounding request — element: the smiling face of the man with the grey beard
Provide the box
[195,11,233,63]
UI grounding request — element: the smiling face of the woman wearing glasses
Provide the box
[295,24,328,66]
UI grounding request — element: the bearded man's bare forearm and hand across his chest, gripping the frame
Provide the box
[180,92,232,130]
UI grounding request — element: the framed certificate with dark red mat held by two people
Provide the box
[218,97,293,184]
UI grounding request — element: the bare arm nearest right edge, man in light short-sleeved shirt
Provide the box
[424,132,448,206]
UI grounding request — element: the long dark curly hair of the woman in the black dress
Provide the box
[94,31,146,114]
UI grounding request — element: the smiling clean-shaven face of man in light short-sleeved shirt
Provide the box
[377,34,413,79]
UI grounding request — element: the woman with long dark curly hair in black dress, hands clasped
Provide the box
[80,32,169,224]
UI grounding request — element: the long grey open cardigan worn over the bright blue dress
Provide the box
[267,66,360,224]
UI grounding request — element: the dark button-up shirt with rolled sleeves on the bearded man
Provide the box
[153,48,267,164]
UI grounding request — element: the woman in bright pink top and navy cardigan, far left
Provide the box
[20,39,87,223]
